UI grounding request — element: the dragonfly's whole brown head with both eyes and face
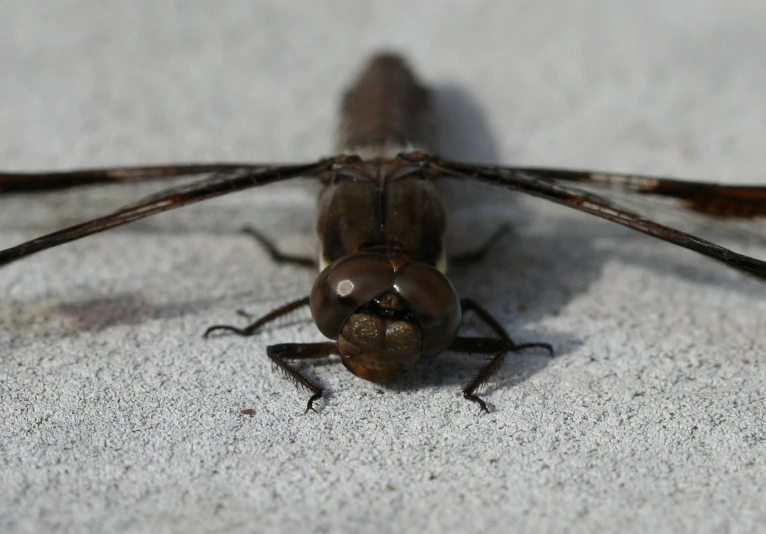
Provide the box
[311,253,461,382]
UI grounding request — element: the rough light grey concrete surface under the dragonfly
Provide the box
[0,0,766,533]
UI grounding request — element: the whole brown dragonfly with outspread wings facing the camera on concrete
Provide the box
[0,53,766,411]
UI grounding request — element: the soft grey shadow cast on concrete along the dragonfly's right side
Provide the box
[268,85,609,397]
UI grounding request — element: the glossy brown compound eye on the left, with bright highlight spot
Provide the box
[310,252,395,339]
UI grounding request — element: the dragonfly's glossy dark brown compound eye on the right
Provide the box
[394,262,461,356]
